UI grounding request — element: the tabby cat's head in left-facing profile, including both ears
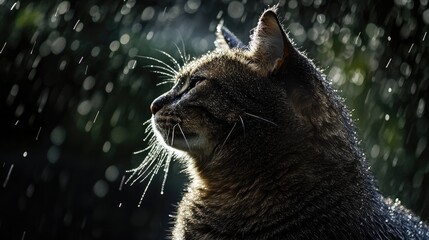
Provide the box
[151,8,348,169]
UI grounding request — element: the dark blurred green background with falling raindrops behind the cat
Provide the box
[0,0,429,239]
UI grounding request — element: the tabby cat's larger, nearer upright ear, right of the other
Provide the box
[249,6,295,73]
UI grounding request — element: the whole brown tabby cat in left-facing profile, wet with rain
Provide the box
[145,6,429,239]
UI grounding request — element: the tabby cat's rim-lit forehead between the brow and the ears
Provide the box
[178,49,258,77]
